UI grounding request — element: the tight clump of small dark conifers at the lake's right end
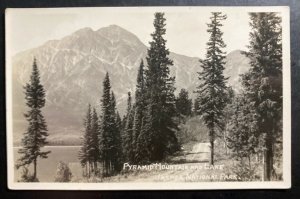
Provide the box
[79,73,123,177]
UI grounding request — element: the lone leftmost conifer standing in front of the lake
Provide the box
[16,59,50,180]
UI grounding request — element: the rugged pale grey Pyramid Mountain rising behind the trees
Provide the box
[12,25,248,144]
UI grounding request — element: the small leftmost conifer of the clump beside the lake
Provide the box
[78,104,92,177]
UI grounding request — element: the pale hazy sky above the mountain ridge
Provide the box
[6,7,250,58]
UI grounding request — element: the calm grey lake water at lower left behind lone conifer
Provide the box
[14,146,81,182]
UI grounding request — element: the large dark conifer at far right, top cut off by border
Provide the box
[243,13,282,180]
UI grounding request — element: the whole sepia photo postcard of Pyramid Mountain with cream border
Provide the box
[5,7,291,190]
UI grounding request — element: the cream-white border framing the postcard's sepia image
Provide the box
[5,6,291,190]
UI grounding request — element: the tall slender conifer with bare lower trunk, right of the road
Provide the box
[197,12,227,165]
